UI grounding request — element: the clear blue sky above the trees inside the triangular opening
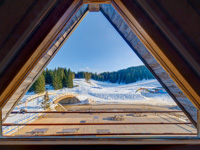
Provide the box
[47,12,143,73]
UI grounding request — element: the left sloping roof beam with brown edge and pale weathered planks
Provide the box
[0,1,88,121]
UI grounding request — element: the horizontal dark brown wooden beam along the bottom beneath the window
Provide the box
[0,135,200,145]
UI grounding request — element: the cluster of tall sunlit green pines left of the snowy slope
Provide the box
[29,67,75,93]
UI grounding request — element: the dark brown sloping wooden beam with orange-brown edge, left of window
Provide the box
[0,0,81,108]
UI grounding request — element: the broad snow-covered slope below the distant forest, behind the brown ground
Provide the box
[46,79,176,105]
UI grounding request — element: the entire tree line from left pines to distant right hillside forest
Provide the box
[29,66,154,93]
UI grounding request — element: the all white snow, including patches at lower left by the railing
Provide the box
[3,79,176,134]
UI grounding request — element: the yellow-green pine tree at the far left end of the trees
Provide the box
[34,74,45,93]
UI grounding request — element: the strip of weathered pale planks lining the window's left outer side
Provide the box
[2,4,88,120]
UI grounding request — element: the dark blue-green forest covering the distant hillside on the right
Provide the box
[75,66,155,84]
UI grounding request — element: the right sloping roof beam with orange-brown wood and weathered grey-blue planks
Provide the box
[98,0,199,126]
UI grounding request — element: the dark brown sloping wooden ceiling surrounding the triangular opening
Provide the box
[0,0,200,132]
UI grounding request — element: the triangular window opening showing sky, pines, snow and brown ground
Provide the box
[3,4,196,136]
